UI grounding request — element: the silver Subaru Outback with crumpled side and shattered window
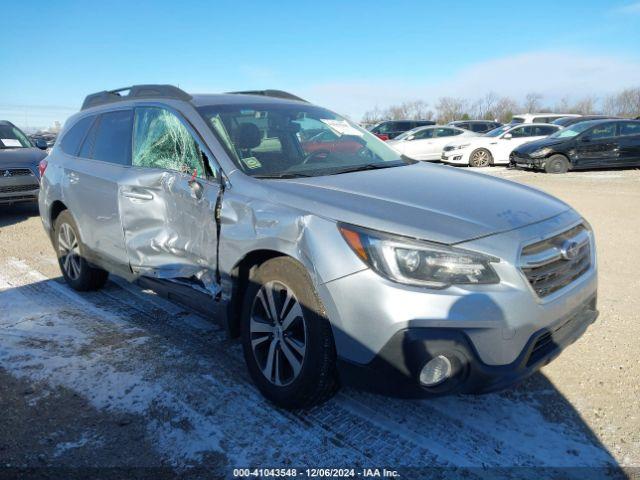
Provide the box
[39,85,597,408]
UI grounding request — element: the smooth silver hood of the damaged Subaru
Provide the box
[263,163,570,244]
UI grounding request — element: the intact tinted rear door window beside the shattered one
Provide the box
[91,110,133,165]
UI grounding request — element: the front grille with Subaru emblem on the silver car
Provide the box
[520,225,591,297]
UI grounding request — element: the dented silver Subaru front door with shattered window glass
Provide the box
[119,106,219,293]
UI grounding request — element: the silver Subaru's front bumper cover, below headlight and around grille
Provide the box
[319,209,597,396]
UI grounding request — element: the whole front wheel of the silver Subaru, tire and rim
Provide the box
[242,257,337,409]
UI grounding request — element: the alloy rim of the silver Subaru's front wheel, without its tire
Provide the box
[249,281,307,387]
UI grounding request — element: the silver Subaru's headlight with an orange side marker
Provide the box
[339,224,500,288]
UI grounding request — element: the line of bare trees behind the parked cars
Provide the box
[362,87,640,124]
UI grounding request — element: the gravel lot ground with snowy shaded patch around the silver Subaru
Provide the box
[0,167,640,478]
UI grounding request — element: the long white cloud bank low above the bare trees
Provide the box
[297,51,640,119]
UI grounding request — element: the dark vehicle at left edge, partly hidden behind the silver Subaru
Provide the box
[0,120,47,205]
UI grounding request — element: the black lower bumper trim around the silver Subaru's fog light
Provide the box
[339,296,598,397]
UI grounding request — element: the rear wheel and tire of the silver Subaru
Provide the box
[53,210,109,292]
